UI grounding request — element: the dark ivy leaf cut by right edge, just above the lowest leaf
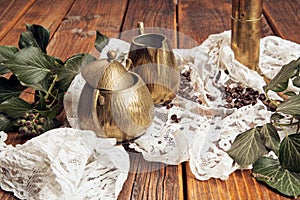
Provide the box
[279,133,300,173]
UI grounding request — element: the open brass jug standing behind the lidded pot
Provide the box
[128,22,180,104]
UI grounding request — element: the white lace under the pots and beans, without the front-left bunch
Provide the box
[65,31,300,180]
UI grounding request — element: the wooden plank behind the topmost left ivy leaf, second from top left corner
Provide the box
[0,0,74,46]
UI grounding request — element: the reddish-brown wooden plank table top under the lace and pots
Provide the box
[0,0,300,200]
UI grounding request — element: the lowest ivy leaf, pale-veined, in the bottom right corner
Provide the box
[253,157,300,198]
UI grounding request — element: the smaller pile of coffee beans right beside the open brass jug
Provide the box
[178,69,202,104]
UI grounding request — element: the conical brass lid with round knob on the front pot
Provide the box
[81,50,134,90]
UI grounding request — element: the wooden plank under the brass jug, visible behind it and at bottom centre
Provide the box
[119,0,184,200]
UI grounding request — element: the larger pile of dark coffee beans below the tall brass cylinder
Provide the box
[223,85,274,111]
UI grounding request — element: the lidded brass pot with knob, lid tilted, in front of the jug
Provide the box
[78,51,154,142]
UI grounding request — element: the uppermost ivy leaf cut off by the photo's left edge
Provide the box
[0,46,19,75]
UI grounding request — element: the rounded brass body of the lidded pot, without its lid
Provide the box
[78,72,154,142]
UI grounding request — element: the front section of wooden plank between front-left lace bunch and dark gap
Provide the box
[118,152,183,200]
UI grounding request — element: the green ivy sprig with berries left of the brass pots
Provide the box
[0,24,101,135]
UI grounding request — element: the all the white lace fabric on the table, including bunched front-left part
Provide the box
[0,31,300,199]
